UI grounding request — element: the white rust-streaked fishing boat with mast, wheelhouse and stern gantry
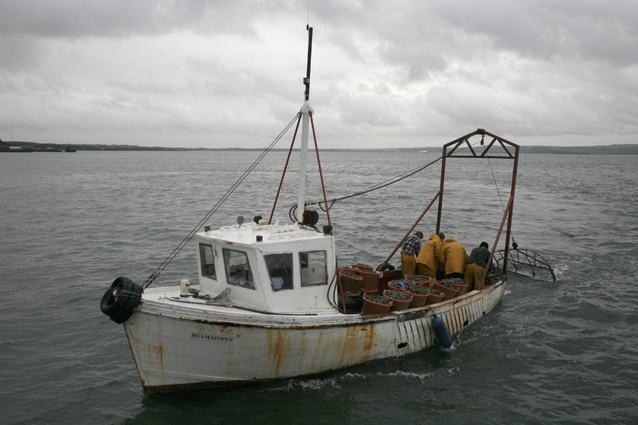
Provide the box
[100,28,519,394]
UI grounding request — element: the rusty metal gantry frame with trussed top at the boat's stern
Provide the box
[386,128,520,289]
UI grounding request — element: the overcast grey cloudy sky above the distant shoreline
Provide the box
[0,0,638,148]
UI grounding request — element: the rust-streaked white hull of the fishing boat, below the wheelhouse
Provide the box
[124,280,506,393]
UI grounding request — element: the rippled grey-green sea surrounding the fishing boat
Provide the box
[0,147,638,425]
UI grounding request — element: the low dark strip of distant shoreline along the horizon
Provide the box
[0,141,638,155]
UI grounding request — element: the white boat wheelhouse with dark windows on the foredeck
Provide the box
[195,221,337,314]
